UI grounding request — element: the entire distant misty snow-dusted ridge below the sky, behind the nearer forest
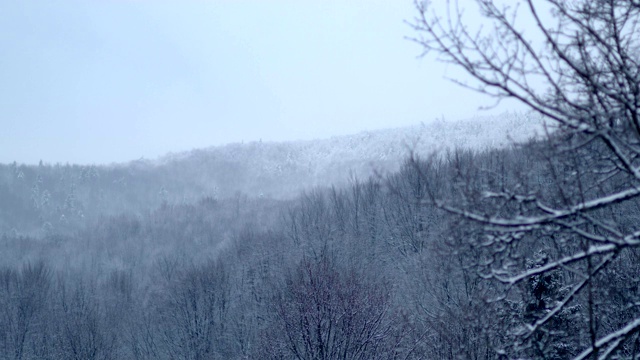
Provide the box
[0,113,543,233]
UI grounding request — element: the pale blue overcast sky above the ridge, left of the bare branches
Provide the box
[0,0,524,164]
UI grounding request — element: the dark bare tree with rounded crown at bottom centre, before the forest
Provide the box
[263,256,393,359]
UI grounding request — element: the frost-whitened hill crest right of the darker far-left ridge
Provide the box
[155,113,544,197]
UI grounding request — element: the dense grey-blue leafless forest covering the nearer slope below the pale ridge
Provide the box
[0,131,640,359]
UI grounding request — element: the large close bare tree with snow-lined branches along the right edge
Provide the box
[412,0,640,359]
